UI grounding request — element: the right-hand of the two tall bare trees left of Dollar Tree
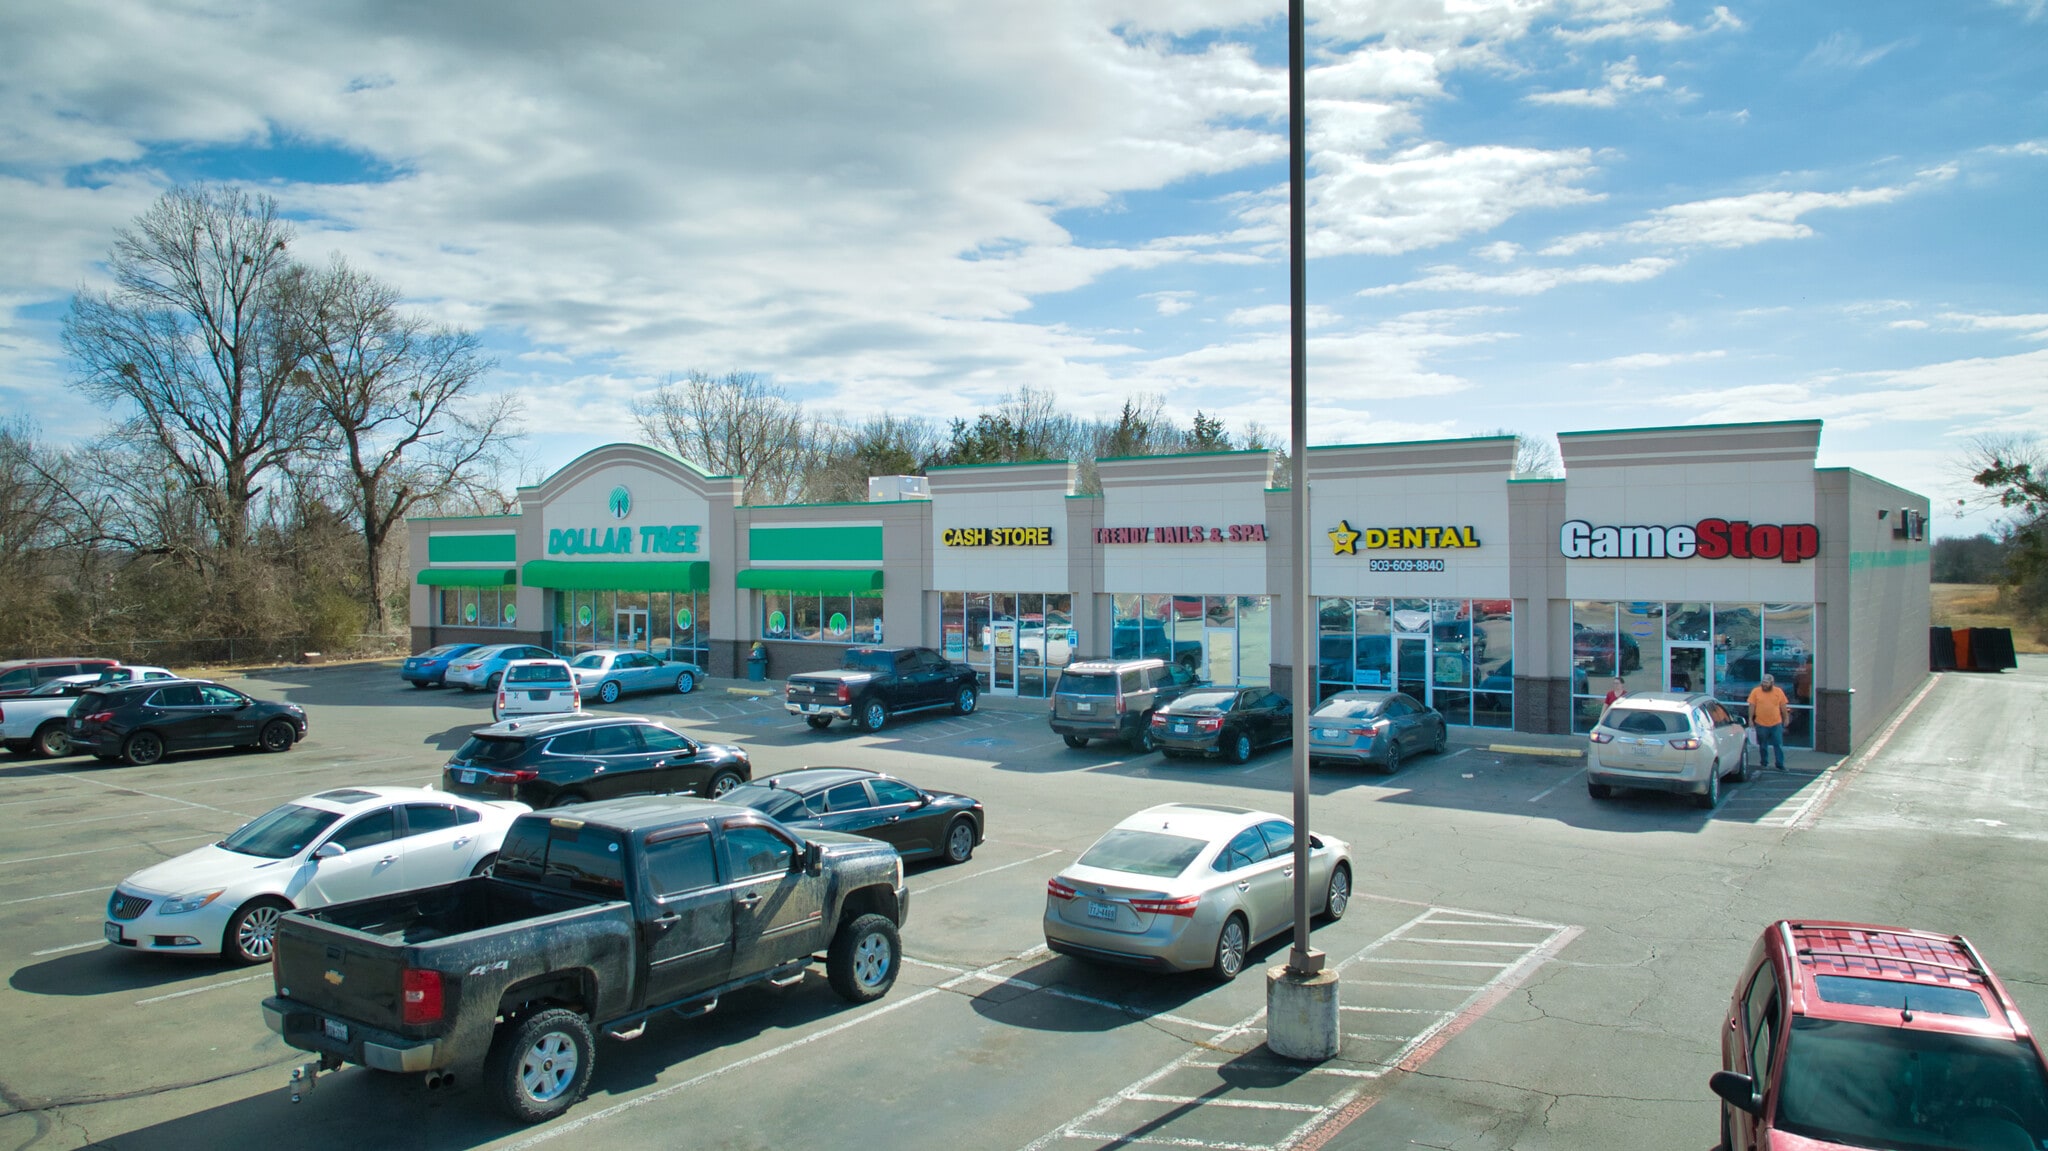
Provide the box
[281,258,520,633]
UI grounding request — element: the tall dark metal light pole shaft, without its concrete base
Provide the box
[1286,0,1323,975]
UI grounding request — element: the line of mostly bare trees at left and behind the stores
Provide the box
[0,184,1556,662]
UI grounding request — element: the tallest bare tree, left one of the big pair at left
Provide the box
[63,186,319,557]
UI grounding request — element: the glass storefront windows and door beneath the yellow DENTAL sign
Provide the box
[1317,596,1516,727]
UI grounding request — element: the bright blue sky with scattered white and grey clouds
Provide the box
[0,0,2048,537]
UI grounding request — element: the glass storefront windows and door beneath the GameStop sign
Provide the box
[1571,600,1815,748]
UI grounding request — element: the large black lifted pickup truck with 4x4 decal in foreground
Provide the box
[262,797,909,1122]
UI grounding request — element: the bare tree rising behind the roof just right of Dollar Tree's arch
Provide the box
[633,371,834,504]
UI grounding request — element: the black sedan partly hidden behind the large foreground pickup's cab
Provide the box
[723,768,983,862]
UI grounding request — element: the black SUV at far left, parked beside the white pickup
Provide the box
[68,680,305,766]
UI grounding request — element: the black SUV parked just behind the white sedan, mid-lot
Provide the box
[440,713,754,807]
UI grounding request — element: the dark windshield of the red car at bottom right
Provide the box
[1778,1016,2048,1151]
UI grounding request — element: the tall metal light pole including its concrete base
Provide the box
[1266,0,1343,1061]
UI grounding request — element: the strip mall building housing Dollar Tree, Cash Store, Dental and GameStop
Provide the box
[410,422,1929,752]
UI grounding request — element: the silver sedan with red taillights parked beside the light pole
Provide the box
[1044,803,1352,979]
